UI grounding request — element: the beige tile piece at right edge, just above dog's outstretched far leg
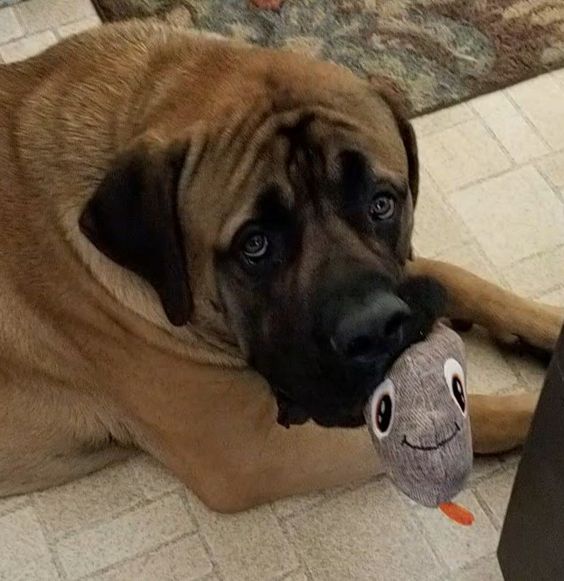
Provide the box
[503,246,564,298]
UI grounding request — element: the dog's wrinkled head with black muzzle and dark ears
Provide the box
[81,44,444,426]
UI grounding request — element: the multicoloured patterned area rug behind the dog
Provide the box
[94,0,564,114]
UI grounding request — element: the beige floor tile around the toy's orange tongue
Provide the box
[415,490,498,570]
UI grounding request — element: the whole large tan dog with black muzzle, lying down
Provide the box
[0,23,562,511]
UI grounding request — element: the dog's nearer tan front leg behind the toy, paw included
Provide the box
[145,393,536,512]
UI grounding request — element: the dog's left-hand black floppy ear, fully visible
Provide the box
[80,138,192,326]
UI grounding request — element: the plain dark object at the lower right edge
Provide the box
[497,332,564,581]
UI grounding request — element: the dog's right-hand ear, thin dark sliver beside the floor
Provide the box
[369,77,419,206]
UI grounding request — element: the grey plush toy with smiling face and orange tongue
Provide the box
[365,324,473,524]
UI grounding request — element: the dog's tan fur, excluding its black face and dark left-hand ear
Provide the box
[0,22,562,511]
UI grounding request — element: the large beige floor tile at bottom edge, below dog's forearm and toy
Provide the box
[288,479,442,581]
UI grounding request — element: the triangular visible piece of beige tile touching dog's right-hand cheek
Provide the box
[413,171,470,258]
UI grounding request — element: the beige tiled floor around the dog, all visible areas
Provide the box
[0,0,564,581]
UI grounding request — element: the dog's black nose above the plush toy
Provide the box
[331,291,411,363]
